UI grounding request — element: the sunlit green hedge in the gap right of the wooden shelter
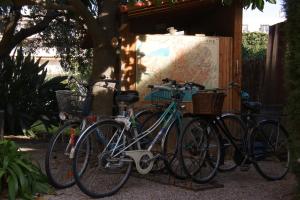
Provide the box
[242,32,268,61]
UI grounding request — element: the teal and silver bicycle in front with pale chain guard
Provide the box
[73,79,211,198]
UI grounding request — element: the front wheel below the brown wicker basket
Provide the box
[179,118,221,183]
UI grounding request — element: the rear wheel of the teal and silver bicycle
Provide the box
[73,120,132,198]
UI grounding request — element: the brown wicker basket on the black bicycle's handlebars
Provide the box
[192,90,226,115]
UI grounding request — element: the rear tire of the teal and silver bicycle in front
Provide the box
[73,120,132,198]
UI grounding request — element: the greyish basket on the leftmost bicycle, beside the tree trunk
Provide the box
[56,90,86,116]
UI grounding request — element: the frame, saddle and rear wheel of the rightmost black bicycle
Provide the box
[215,83,290,180]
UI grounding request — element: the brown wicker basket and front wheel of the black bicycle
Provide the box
[179,89,225,183]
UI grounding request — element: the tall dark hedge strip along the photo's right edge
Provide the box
[284,0,300,197]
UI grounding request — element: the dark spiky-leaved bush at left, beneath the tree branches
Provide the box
[0,50,66,132]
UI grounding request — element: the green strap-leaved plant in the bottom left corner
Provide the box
[0,140,50,200]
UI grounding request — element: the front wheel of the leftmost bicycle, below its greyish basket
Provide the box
[45,121,81,189]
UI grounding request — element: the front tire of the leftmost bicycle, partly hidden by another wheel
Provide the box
[45,120,81,189]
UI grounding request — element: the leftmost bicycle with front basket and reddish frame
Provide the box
[45,76,123,189]
